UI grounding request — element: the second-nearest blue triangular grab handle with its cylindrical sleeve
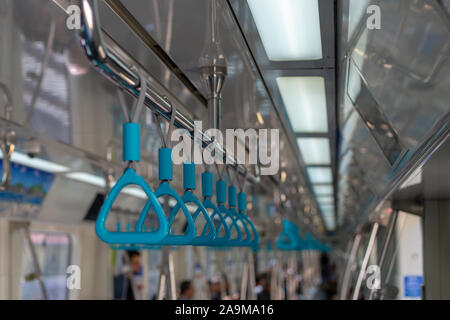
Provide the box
[136,148,196,246]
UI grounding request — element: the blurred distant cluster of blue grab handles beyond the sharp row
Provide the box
[276,219,331,252]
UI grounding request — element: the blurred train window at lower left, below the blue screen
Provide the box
[20,231,72,300]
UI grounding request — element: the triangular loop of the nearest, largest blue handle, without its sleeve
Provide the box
[95,168,168,244]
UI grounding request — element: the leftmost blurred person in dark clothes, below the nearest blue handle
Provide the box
[114,251,143,300]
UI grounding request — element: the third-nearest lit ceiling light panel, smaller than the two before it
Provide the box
[297,138,331,165]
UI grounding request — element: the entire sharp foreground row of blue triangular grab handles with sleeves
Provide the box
[95,122,259,250]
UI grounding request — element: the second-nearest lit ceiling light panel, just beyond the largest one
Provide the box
[277,77,328,133]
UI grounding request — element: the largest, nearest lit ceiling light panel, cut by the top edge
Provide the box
[247,0,323,61]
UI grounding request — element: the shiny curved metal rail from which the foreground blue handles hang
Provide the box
[79,0,260,183]
